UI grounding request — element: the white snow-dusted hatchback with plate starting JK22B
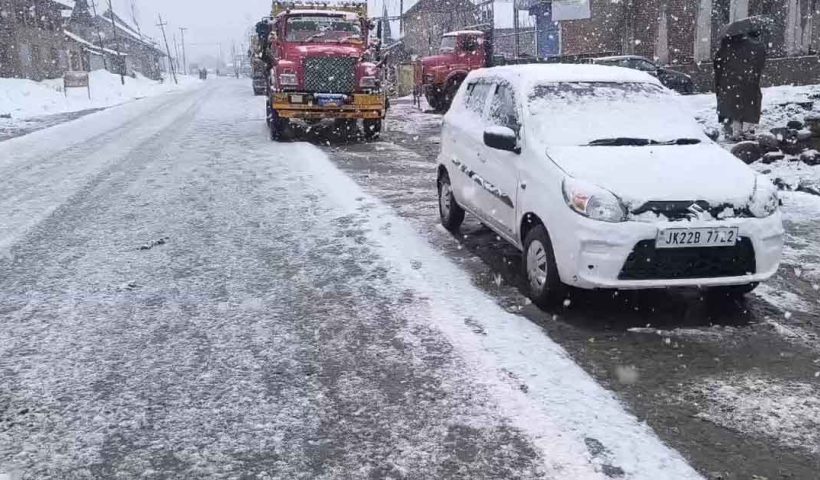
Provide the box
[438,65,783,306]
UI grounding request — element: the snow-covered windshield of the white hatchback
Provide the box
[525,82,707,146]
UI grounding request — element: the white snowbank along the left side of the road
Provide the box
[0,70,199,120]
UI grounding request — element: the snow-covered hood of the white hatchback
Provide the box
[547,143,755,208]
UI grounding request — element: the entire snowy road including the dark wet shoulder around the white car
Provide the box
[0,80,820,480]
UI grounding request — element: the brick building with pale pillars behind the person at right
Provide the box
[522,0,820,64]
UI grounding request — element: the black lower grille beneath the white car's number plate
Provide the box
[618,237,757,280]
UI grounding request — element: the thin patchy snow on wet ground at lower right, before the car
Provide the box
[687,375,820,454]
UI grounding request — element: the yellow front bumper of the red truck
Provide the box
[272,93,387,120]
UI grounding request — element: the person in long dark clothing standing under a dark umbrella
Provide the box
[714,17,769,141]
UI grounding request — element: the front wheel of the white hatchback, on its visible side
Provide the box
[521,225,567,308]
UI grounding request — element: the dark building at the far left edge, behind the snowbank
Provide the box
[0,0,70,80]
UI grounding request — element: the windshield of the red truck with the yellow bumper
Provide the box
[285,15,362,43]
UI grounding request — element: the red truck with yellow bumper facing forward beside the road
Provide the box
[261,0,387,140]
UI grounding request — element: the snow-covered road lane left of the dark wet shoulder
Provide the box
[0,81,698,479]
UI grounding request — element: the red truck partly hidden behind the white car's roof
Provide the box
[415,30,486,111]
